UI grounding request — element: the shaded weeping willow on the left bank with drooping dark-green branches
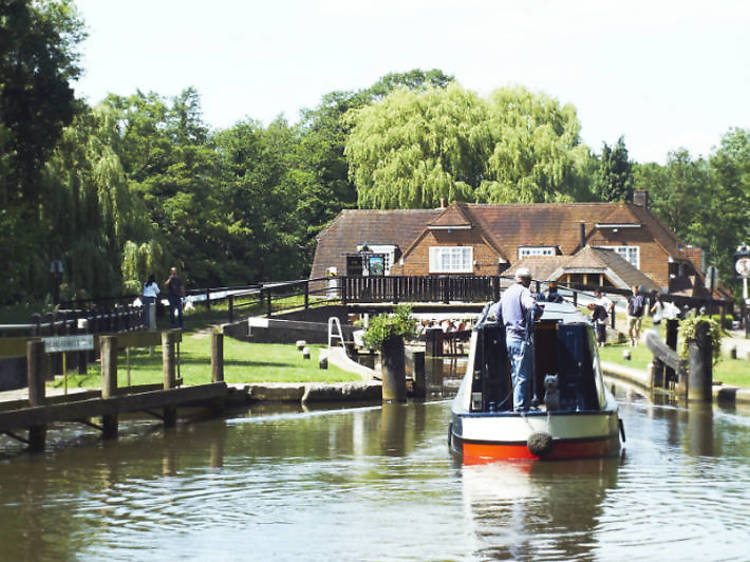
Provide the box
[43,105,164,298]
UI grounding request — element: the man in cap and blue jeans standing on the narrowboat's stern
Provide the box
[497,267,544,411]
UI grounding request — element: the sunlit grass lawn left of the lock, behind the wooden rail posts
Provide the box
[52,332,361,388]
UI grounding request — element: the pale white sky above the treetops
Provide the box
[75,0,750,163]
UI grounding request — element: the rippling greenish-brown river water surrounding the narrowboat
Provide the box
[0,364,750,562]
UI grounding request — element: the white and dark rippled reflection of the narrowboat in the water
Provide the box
[461,458,619,560]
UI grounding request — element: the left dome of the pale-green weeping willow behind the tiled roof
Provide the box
[344,84,492,209]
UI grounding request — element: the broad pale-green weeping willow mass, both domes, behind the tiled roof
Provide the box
[345,84,592,208]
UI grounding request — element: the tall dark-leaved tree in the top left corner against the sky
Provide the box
[0,0,85,209]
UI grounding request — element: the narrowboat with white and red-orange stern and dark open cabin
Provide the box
[448,302,625,464]
